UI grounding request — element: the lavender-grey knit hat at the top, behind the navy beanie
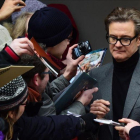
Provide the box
[12,0,47,24]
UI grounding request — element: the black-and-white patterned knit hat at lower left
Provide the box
[0,76,28,111]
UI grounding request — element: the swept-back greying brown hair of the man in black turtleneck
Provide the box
[105,7,140,34]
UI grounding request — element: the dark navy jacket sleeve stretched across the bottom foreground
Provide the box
[12,115,82,140]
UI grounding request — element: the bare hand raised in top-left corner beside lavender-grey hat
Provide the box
[0,0,25,21]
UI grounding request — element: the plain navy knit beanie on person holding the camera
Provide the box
[28,7,72,47]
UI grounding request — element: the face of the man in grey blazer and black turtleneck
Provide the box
[109,21,140,62]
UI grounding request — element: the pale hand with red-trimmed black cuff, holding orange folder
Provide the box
[10,38,34,56]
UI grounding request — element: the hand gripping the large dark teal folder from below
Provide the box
[77,87,98,106]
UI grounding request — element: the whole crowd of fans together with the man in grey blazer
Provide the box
[0,0,140,140]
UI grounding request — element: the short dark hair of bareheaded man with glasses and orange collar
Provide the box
[19,54,46,84]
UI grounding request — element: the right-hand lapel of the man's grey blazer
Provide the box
[123,60,140,118]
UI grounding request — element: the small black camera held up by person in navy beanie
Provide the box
[73,41,92,58]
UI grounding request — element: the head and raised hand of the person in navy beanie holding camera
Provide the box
[28,7,84,81]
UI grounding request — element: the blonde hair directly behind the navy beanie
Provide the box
[11,12,33,39]
